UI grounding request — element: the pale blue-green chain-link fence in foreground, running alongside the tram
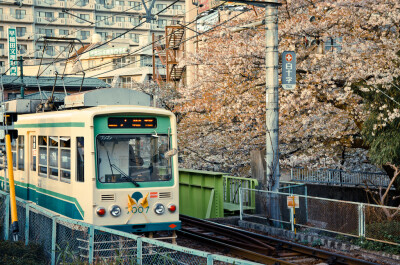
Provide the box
[0,191,259,265]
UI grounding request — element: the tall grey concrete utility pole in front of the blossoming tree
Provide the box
[265,0,281,192]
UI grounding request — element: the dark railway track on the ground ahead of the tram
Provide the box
[178,215,376,265]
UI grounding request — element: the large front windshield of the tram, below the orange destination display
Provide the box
[96,134,172,186]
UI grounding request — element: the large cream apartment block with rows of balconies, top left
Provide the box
[0,0,185,72]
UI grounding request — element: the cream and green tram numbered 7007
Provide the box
[0,89,180,232]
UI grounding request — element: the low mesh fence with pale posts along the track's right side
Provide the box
[240,189,400,246]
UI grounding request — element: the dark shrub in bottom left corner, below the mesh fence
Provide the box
[0,241,46,265]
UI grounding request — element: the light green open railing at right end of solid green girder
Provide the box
[223,175,258,212]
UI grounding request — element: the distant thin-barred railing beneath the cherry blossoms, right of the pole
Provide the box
[291,167,390,188]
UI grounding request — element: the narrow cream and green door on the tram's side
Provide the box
[26,132,38,203]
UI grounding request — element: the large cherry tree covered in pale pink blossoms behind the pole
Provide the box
[173,0,400,175]
